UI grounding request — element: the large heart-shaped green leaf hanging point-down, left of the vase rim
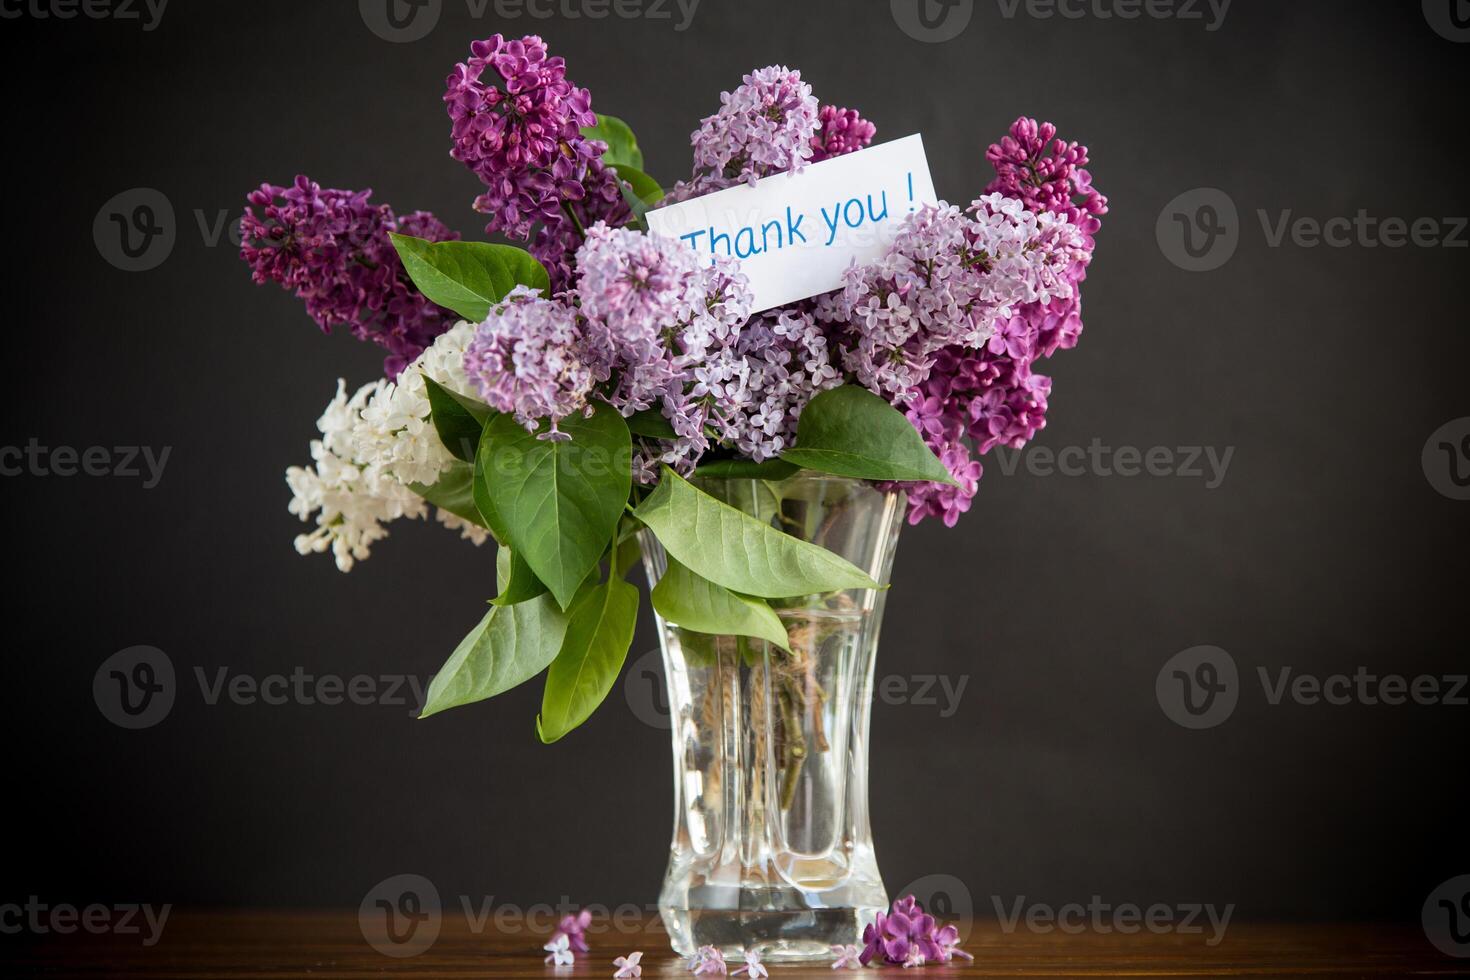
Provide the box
[475,403,632,608]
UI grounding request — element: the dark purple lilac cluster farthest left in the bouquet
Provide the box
[240,175,459,378]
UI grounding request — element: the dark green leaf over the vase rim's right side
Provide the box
[781,385,954,485]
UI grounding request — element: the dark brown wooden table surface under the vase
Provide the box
[0,909,1470,980]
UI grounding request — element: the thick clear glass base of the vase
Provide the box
[659,907,879,965]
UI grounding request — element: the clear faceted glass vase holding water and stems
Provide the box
[642,473,904,962]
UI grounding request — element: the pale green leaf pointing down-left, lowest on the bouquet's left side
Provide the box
[419,597,567,718]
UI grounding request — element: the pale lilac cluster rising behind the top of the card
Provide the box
[672,65,819,201]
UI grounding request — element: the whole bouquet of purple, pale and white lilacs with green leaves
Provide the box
[241,35,1107,741]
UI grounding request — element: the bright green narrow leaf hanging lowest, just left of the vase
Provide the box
[537,579,638,743]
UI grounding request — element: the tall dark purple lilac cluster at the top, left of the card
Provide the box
[444,34,631,289]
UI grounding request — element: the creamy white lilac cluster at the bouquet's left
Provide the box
[285,322,487,572]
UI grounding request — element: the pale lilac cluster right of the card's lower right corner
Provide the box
[817,194,1085,403]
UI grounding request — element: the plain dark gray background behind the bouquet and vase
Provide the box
[0,0,1470,920]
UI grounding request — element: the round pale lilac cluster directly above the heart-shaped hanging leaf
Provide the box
[465,287,607,439]
